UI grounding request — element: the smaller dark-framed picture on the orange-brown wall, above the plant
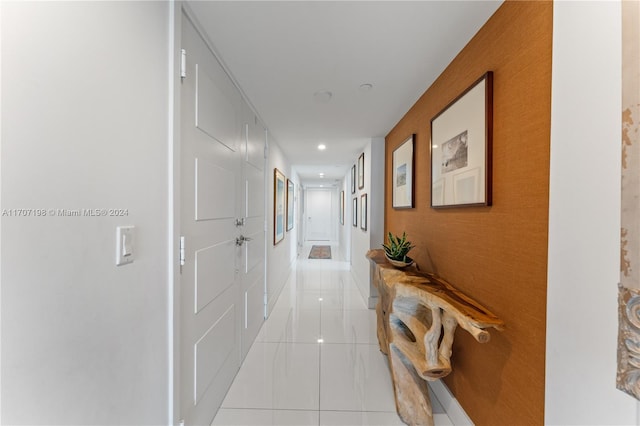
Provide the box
[391,135,415,209]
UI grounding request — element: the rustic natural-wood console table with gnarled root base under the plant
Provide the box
[367,249,504,425]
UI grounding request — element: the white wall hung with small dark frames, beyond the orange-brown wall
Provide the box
[348,138,384,308]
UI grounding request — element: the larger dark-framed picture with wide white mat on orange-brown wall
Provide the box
[431,71,493,208]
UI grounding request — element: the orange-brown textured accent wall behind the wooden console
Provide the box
[385,2,553,425]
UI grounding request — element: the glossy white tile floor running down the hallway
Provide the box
[212,245,452,426]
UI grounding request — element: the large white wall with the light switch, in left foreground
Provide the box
[0,2,172,424]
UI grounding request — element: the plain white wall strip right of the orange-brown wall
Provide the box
[545,1,637,425]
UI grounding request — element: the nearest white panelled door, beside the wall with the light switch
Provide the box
[180,15,244,425]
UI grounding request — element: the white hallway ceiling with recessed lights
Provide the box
[189,0,502,182]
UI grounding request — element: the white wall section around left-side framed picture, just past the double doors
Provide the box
[267,137,300,312]
